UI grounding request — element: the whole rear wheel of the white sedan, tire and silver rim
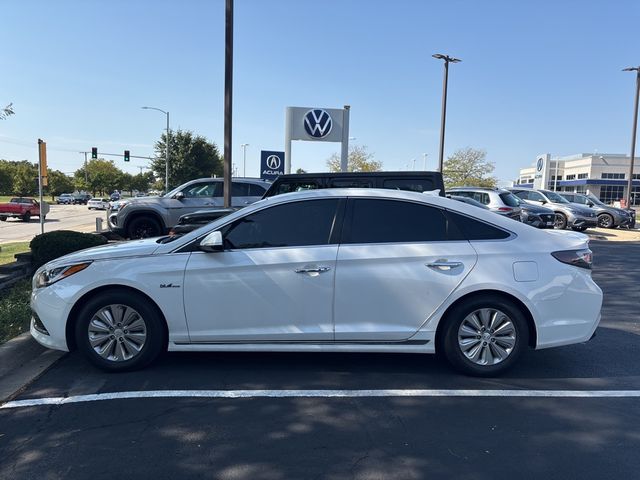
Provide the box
[440,295,529,377]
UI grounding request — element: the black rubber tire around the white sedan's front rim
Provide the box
[75,290,167,372]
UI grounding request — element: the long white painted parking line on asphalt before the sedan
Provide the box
[0,389,640,410]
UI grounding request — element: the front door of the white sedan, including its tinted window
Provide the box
[184,199,342,343]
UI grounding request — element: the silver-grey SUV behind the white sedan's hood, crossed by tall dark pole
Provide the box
[107,178,270,238]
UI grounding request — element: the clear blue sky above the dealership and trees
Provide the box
[0,0,640,181]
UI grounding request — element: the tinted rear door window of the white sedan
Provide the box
[343,199,450,243]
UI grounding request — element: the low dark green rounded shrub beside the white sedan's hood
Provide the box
[29,230,107,268]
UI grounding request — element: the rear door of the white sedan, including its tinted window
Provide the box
[334,198,477,341]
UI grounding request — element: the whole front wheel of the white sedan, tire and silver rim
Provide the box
[75,291,166,372]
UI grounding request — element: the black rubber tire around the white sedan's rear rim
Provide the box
[438,295,529,377]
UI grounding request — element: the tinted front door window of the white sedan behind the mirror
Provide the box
[221,199,339,249]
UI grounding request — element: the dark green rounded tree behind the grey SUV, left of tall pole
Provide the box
[151,130,222,189]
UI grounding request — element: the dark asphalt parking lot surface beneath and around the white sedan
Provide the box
[0,242,640,479]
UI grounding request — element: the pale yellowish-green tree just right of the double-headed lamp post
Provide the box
[442,147,498,188]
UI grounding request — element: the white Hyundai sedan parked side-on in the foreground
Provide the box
[31,189,602,376]
